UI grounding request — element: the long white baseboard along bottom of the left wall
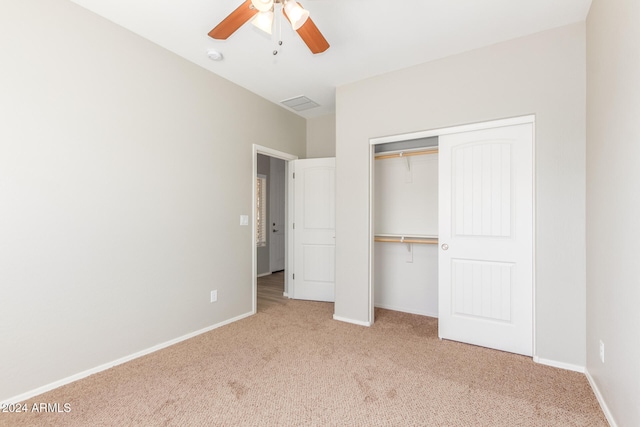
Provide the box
[0,312,254,405]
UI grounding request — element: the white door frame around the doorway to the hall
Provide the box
[250,144,298,314]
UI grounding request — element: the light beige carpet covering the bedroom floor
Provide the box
[0,277,607,427]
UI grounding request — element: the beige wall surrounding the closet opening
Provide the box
[335,23,586,368]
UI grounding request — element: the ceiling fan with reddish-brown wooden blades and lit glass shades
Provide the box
[209,0,329,54]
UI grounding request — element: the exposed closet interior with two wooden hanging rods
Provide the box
[373,137,438,317]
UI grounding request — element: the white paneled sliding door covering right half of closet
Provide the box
[438,123,533,356]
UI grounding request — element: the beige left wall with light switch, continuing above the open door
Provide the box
[0,0,306,401]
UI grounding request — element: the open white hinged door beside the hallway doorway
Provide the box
[289,158,336,302]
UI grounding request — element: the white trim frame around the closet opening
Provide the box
[369,115,537,360]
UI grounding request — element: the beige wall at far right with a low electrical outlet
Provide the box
[586,0,640,426]
